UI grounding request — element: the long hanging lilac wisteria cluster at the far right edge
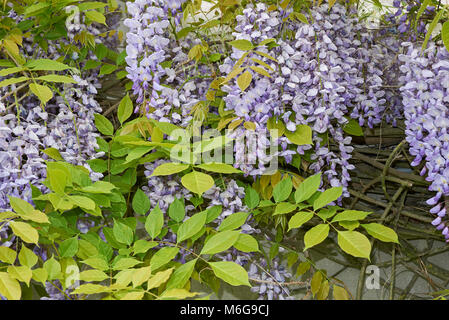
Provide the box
[399,42,449,241]
